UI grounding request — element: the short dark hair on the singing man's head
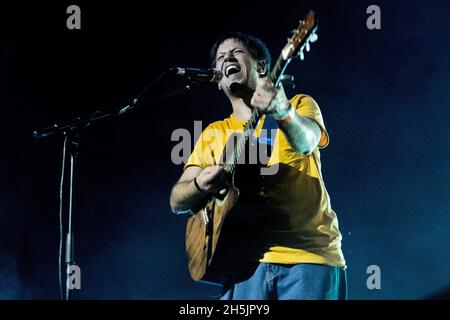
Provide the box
[210,31,272,70]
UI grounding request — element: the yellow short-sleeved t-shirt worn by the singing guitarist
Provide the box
[185,94,345,268]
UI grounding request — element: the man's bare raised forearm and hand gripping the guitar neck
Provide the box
[251,78,321,155]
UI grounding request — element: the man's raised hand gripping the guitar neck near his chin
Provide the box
[250,77,290,117]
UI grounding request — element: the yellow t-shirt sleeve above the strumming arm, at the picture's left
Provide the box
[183,126,216,170]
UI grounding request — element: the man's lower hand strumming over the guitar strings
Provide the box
[196,166,229,195]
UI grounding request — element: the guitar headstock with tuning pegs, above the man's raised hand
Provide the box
[281,10,318,61]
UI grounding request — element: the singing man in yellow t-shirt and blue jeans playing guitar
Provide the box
[170,32,347,300]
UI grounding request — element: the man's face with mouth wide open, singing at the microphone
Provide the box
[216,39,262,94]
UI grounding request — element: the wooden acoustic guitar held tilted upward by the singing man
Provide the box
[186,11,318,285]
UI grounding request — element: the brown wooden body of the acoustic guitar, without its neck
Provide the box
[186,181,258,284]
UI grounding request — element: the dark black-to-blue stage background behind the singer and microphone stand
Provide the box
[0,0,450,299]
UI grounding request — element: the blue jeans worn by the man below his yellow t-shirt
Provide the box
[220,262,347,300]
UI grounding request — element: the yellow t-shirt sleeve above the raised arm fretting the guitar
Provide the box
[291,94,330,148]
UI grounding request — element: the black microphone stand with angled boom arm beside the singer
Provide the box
[33,69,198,300]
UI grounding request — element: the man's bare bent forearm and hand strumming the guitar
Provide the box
[170,166,227,213]
